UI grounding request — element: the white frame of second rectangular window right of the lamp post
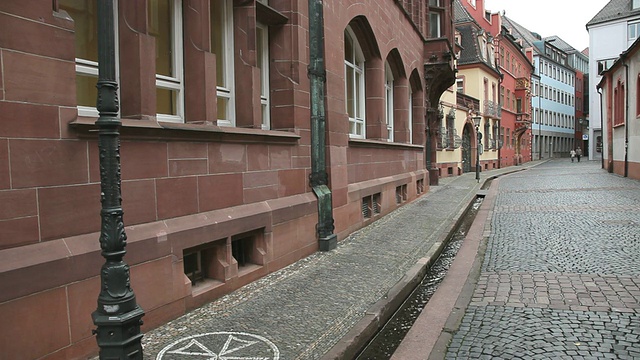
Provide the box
[216,0,236,126]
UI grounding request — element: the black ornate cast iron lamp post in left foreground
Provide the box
[92,0,144,359]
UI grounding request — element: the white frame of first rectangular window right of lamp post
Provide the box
[156,0,184,122]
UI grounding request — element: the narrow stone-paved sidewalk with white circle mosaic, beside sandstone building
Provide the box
[143,164,535,359]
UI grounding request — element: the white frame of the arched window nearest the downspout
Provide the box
[344,26,366,139]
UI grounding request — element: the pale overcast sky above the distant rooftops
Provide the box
[485,0,609,51]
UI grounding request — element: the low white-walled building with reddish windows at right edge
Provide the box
[597,40,640,180]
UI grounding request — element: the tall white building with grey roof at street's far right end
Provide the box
[587,0,640,160]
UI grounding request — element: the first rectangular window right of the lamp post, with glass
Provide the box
[152,0,184,121]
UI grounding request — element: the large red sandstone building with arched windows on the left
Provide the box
[0,0,455,359]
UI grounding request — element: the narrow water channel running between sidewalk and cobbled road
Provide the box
[356,195,488,360]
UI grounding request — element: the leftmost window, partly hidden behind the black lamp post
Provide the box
[58,0,119,117]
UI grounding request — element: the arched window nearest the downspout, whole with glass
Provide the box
[344,27,365,139]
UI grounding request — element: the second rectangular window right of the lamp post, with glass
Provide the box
[209,0,235,126]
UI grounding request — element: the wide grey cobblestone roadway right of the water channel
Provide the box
[446,160,640,359]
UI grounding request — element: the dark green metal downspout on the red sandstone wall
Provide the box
[308,0,338,251]
